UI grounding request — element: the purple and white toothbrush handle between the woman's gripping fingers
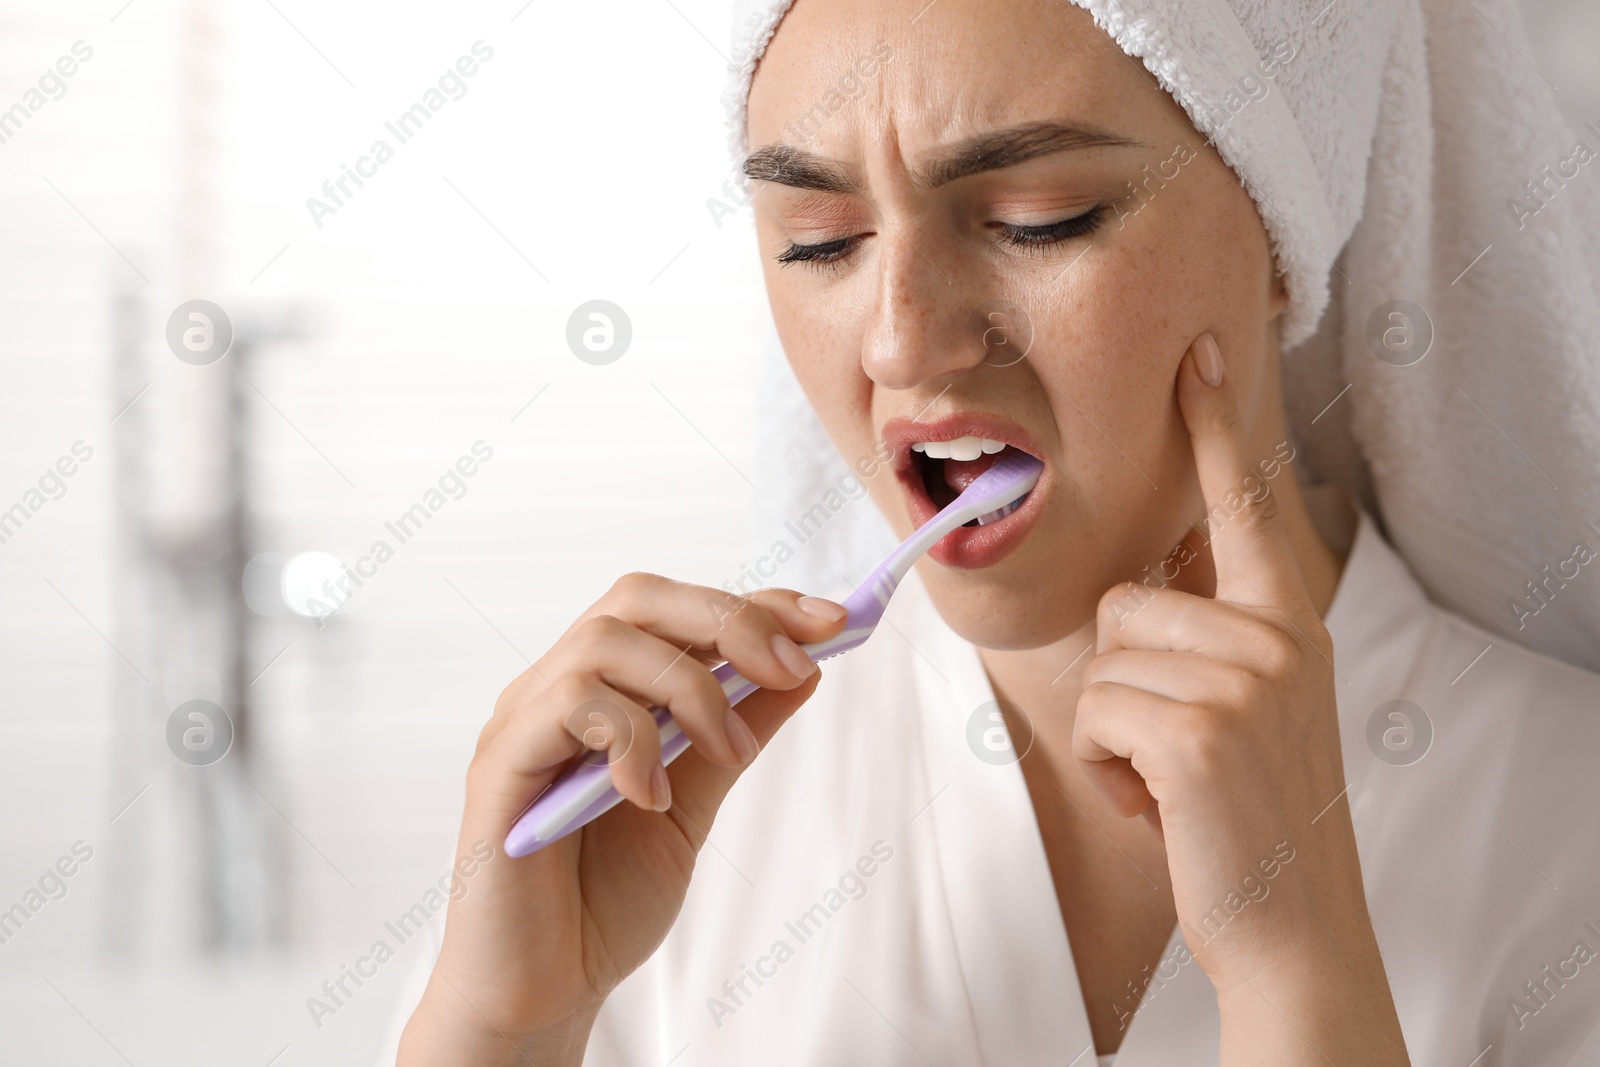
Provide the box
[506,613,877,859]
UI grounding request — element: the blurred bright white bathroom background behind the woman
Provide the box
[0,0,1600,1067]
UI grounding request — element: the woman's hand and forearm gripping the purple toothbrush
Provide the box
[398,585,845,1067]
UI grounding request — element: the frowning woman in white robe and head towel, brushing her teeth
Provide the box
[387,0,1600,1067]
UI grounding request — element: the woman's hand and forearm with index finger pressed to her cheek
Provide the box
[1074,334,1406,1064]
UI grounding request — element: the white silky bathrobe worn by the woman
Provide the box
[379,495,1600,1067]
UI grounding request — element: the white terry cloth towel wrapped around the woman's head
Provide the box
[726,0,1600,670]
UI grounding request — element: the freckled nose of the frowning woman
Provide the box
[861,224,986,390]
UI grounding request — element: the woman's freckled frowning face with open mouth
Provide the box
[746,0,1285,648]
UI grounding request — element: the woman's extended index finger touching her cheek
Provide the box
[1178,333,1306,617]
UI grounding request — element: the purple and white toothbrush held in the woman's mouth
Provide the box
[506,451,1045,857]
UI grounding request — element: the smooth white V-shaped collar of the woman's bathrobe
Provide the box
[906,510,1429,1067]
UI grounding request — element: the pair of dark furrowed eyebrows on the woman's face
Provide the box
[744,122,1142,194]
